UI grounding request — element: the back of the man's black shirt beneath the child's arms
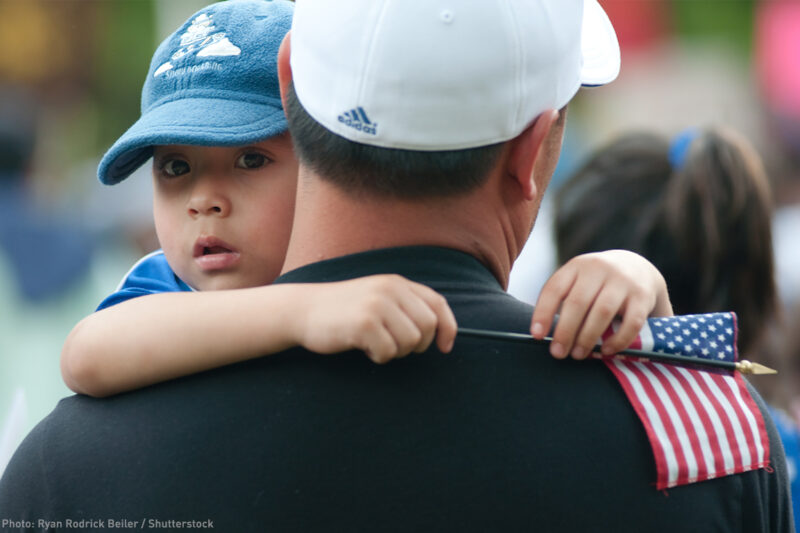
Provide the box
[0,248,791,532]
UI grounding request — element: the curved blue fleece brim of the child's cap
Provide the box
[97,97,288,185]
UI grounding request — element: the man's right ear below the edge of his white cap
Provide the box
[507,109,558,200]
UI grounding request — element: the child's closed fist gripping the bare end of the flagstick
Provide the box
[299,274,456,364]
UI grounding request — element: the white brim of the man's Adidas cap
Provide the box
[581,0,621,87]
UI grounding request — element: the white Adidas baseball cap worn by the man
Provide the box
[291,0,620,151]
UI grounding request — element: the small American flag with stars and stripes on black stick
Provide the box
[604,313,769,489]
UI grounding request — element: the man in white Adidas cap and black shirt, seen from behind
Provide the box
[0,0,791,532]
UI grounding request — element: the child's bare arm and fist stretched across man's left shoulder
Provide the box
[61,275,456,397]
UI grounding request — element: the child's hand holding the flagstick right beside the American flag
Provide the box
[531,250,672,359]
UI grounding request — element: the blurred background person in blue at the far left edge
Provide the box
[0,85,94,472]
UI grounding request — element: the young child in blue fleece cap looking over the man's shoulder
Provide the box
[61,0,671,396]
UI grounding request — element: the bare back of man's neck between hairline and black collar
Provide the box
[283,169,519,287]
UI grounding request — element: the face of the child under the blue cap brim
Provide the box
[153,135,297,290]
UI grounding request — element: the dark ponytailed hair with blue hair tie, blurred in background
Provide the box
[555,128,777,351]
